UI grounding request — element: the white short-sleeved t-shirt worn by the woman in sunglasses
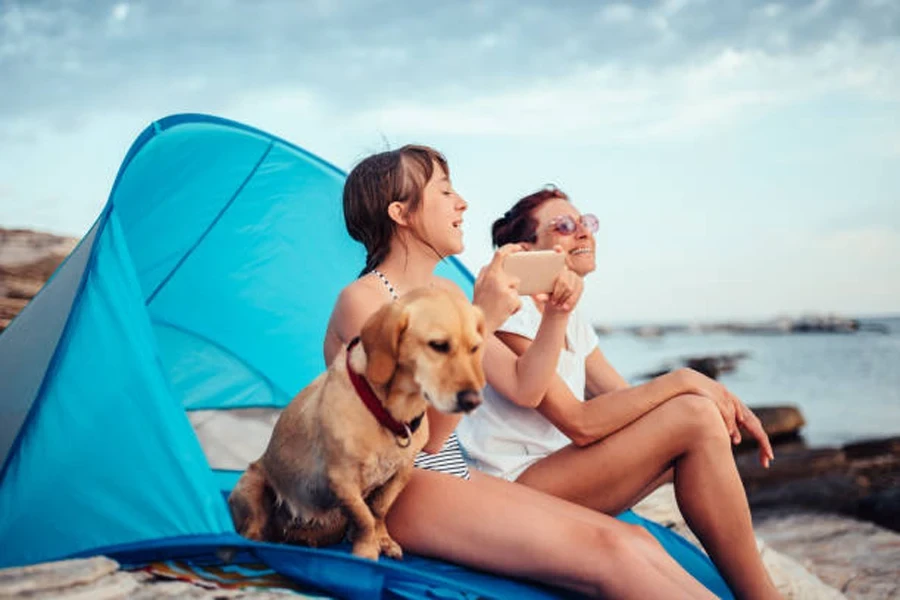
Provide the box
[457,297,597,481]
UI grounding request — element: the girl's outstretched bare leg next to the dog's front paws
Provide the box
[387,469,713,598]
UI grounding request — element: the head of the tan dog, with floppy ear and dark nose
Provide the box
[360,288,485,413]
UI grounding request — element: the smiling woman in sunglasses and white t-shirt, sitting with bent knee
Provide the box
[458,187,778,598]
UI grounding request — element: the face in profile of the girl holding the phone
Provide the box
[413,163,469,256]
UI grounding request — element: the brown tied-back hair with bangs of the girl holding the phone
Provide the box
[344,145,450,275]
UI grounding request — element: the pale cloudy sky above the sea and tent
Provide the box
[0,0,900,324]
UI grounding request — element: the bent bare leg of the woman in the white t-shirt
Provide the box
[518,395,778,598]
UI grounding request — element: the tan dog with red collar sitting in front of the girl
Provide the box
[228,289,485,559]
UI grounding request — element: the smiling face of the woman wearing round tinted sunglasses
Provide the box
[531,198,597,277]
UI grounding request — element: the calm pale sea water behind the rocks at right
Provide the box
[600,317,900,446]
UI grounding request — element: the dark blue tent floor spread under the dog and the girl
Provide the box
[56,511,732,600]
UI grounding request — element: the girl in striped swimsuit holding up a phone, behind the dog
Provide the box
[324,146,727,598]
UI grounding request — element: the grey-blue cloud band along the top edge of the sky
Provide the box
[0,0,900,125]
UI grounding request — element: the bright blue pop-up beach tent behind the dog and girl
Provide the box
[0,115,732,598]
